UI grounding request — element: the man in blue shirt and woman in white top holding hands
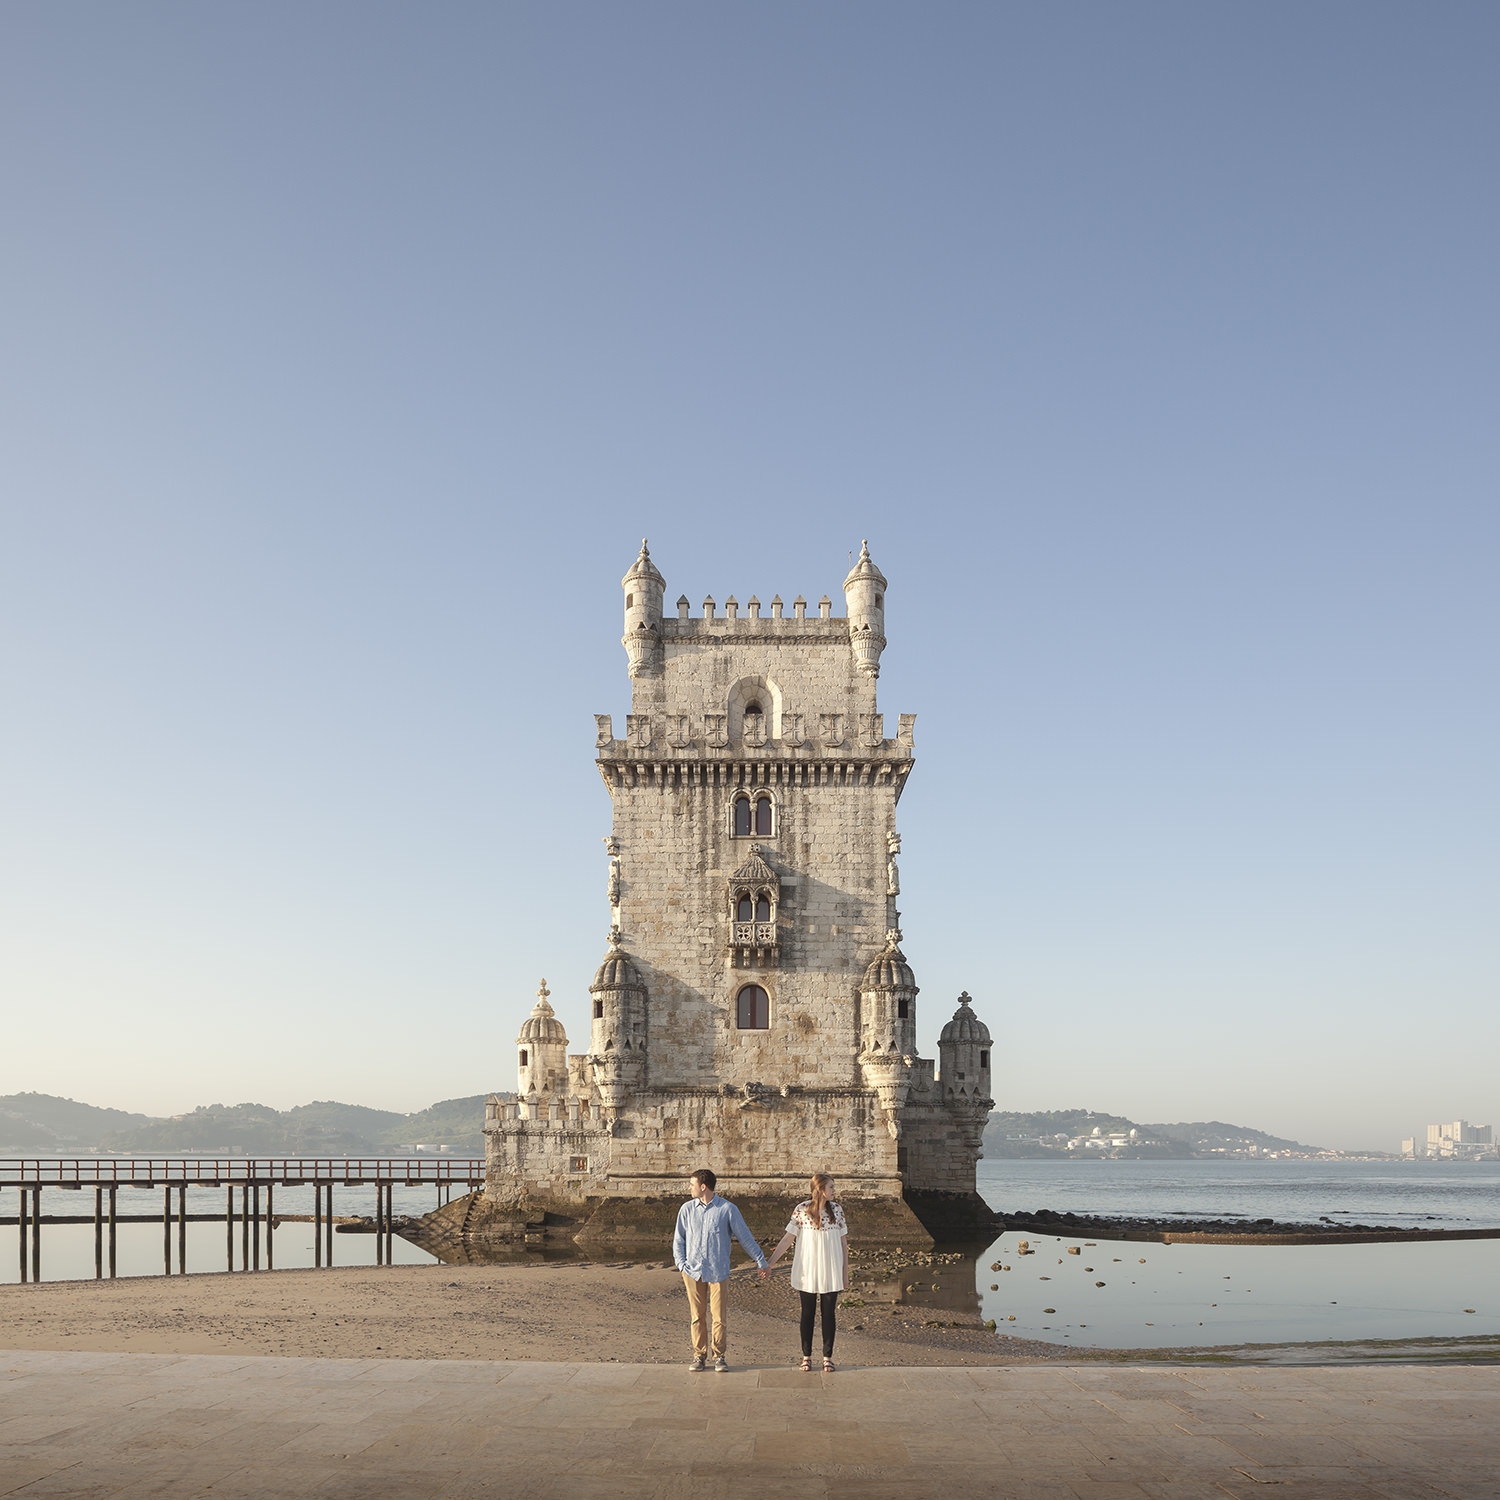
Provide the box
[672,1167,849,1371]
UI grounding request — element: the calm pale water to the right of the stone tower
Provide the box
[948,1161,1500,1347]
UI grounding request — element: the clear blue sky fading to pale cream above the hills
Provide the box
[0,0,1500,1149]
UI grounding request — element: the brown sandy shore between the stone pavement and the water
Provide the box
[0,1260,1500,1368]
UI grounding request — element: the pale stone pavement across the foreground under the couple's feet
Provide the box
[0,1353,1500,1500]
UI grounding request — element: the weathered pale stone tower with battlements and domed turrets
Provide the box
[486,543,992,1230]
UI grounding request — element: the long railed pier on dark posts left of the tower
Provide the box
[0,1157,485,1281]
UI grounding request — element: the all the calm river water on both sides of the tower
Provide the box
[11,1160,1500,1349]
